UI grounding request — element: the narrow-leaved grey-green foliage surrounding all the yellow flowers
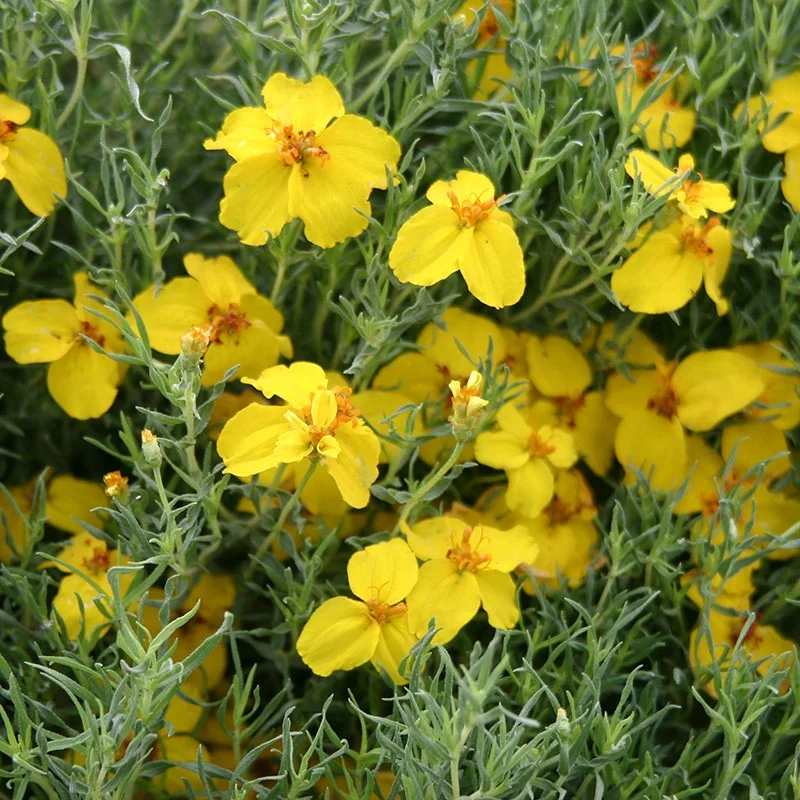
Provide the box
[0,0,800,800]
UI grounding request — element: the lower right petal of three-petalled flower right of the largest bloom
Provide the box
[459,219,525,308]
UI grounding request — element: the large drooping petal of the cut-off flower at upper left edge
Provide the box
[3,128,67,217]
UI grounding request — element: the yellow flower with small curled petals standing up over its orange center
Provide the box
[217,361,380,508]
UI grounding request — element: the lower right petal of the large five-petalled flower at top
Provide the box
[289,152,372,248]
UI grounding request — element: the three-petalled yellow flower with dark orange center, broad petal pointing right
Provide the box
[606,350,764,491]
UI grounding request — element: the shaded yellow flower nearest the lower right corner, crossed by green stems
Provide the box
[689,609,797,698]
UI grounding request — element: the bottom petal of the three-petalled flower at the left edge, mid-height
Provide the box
[47,341,120,419]
